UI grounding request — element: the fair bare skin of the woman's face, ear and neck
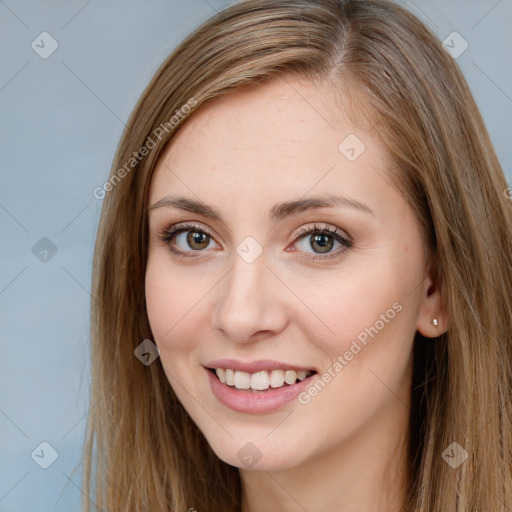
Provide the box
[146,79,446,512]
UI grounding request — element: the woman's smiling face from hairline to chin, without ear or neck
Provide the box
[146,76,434,470]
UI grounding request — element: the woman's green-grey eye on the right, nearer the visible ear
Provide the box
[295,224,352,259]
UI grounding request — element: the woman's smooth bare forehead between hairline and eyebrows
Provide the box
[150,79,387,212]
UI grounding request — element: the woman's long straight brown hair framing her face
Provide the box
[83,0,512,512]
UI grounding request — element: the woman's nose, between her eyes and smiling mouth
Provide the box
[213,249,288,343]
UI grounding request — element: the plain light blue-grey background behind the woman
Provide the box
[0,0,512,512]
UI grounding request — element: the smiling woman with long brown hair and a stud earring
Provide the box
[84,0,512,512]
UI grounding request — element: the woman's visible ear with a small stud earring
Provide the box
[416,269,449,338]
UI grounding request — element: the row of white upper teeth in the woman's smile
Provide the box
[215,368,313,391]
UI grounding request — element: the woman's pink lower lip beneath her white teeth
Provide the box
[206,370,316,414]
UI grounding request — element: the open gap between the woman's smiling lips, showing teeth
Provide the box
[207,367,317,393]
